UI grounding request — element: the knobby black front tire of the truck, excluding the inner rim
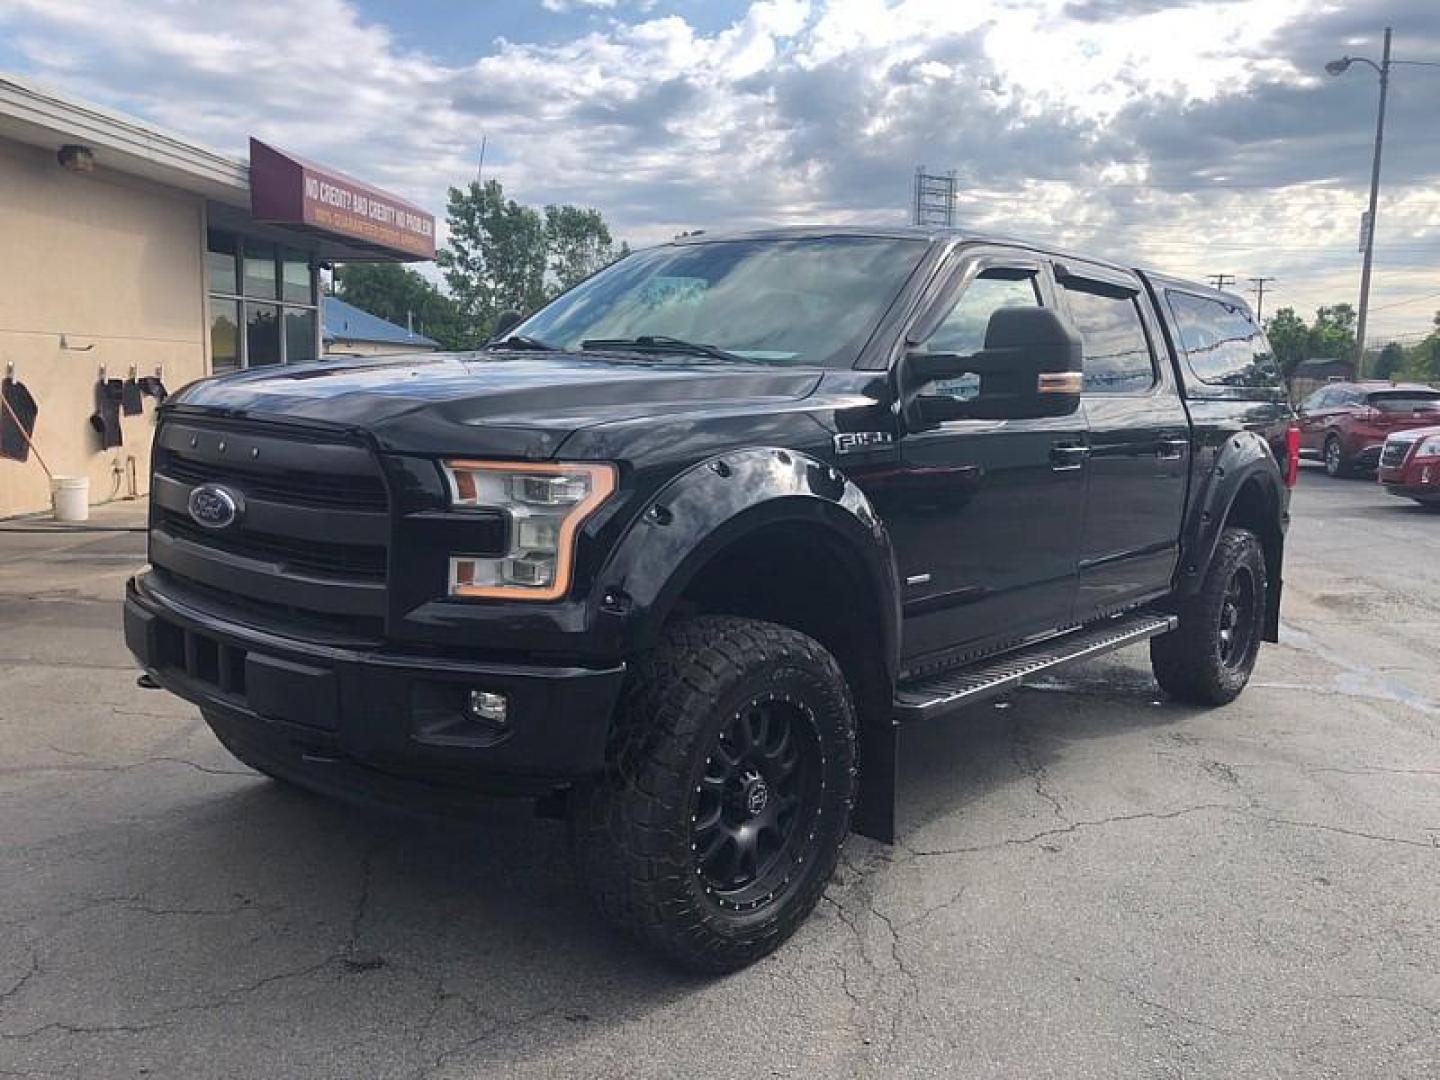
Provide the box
[570,616,855,973]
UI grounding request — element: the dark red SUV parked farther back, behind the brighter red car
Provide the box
[1296,383,1440,477]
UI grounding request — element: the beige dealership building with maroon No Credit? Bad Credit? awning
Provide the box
[0,75,435,517]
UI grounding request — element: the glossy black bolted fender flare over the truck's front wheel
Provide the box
[592,448,900,678]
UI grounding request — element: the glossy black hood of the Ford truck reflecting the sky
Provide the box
[171,351,822,458]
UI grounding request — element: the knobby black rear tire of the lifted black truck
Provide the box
[1151,528,1267,706]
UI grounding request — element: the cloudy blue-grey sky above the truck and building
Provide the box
[0,0,1440,341]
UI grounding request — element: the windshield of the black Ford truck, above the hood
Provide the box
[516,236,926,367]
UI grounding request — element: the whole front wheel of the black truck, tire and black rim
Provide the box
[572,616,855,972]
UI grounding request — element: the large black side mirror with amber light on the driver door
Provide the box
[900,307,1083,428]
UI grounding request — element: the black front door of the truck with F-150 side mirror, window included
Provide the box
[878,248,1086,664]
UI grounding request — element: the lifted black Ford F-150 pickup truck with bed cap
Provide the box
[125,229,1297,971]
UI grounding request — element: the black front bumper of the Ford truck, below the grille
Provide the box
[125,575,625,809]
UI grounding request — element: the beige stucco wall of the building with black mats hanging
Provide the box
[0,141,207,517]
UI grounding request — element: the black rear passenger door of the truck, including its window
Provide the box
[1056,261,1189,621]
